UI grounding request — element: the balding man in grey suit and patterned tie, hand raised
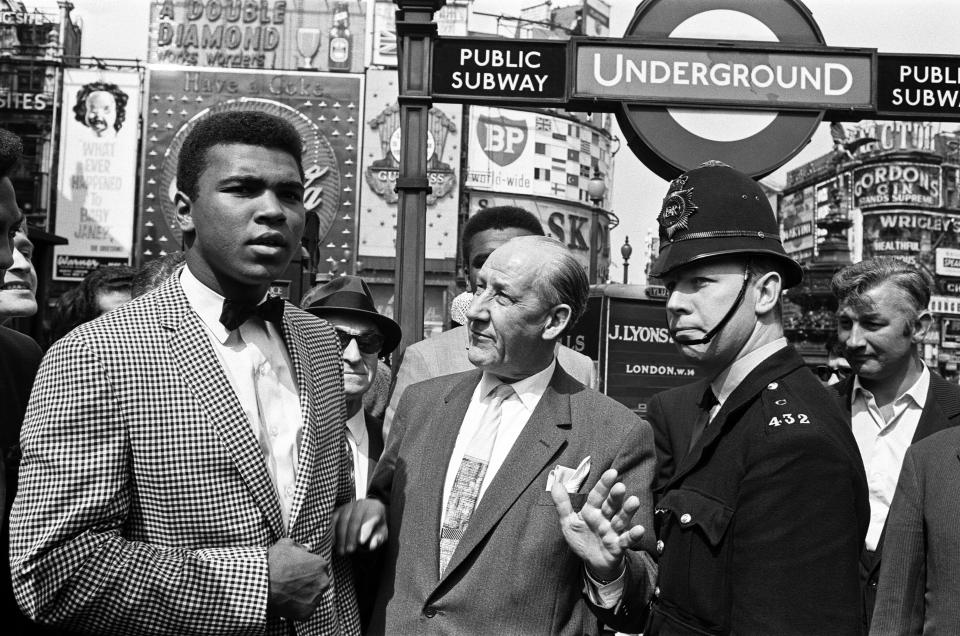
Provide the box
[336,236,655,635]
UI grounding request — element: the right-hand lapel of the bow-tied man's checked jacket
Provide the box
[282,312,320,533]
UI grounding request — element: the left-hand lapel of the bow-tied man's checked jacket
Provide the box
[157,286,284,538]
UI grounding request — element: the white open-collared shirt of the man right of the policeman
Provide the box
[850,365,930,550]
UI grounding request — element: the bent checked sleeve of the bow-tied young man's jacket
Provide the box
[10,336,269,634]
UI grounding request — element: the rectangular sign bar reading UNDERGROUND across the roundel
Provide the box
[571,39,873,111]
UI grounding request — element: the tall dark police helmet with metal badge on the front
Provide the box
[650,161,803,288]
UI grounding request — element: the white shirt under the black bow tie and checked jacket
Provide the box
[180,267,303,527]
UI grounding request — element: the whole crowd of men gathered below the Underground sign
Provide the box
[0,111,960,635]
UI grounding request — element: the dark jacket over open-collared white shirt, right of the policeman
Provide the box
[833,370,960,632]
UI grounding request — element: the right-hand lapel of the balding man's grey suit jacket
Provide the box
[437,366,571,583]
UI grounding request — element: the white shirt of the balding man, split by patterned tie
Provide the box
[440,358,557,528]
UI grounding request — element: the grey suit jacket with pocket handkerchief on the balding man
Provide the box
[369,365,655,636]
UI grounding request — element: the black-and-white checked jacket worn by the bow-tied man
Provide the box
[11,275,359,635]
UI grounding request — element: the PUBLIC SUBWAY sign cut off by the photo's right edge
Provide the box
[876,53,960,121]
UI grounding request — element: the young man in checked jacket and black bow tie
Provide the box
[10,110,360,636]
